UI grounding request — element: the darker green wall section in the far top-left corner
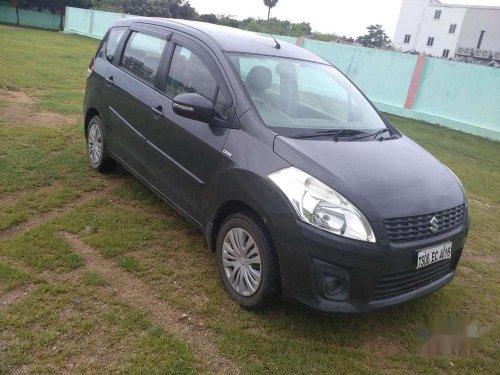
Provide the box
[0,5,61,30]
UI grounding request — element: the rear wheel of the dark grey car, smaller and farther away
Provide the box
[86,116,116,172]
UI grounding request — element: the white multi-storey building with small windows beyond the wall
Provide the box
[393,0,500,60]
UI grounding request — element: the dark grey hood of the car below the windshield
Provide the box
[274,136,464,222]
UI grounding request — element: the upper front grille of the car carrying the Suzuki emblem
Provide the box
[384,204,465,243]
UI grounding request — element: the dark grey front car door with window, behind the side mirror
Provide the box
[146,34,234,222]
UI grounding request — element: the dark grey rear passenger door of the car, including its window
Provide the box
[106,26,167,179]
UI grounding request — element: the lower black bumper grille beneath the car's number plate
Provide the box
[371,250,461,301]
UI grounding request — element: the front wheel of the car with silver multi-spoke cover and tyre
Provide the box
[215,213,279,309]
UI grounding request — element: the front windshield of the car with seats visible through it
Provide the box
[229,53,387,136]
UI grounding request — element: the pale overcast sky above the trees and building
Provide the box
[189,0,500,39]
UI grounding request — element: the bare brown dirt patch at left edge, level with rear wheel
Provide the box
[0,90,77,128]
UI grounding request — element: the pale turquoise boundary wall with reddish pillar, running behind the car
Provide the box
[64,7,500,140]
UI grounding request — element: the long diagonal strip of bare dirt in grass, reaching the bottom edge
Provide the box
[60,232,240,374]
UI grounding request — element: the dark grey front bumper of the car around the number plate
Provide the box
[269,215,468,313]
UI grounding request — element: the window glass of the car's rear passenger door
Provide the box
[121,32,166,83]
